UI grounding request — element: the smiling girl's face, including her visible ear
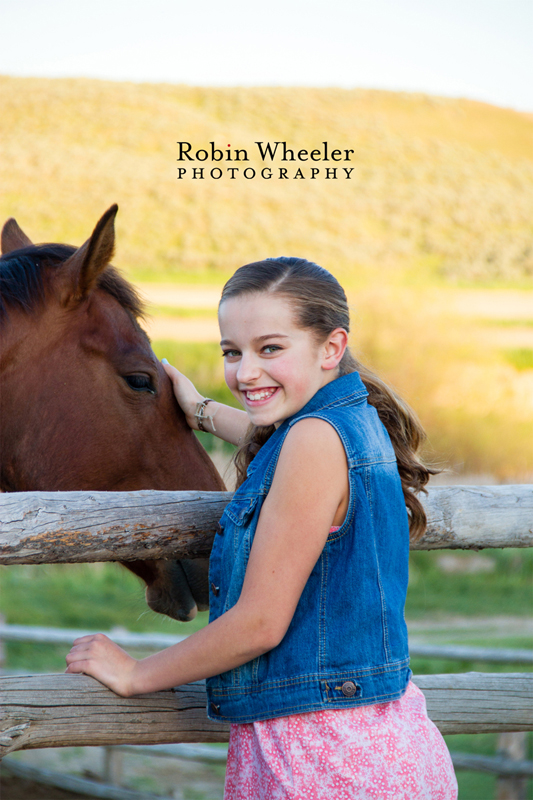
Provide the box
[219,292,347,427]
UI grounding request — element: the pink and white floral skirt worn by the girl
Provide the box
[224,681,457,800]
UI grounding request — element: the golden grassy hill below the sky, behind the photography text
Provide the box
[0,77,533,285]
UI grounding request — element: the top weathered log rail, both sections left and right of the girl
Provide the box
[0,484,533,564]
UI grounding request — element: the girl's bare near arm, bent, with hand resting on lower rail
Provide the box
[67,419,349,697]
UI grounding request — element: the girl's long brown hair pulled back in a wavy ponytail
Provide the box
[220,256,438,541]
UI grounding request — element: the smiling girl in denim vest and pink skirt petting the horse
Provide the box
[67,258,457,800]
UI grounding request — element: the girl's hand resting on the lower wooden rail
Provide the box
[65,633,138,697]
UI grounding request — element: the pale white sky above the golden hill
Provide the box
[0,0,533,112]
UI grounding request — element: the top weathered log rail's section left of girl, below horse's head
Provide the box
[0,491,232,564]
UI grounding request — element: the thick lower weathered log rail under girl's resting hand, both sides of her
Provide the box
[0,672,533,755]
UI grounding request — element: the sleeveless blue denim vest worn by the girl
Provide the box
[206,372,411,723]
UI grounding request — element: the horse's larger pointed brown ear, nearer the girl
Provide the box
[61,204,118,305]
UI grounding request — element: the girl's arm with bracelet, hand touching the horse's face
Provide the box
[162,361,250,445]
